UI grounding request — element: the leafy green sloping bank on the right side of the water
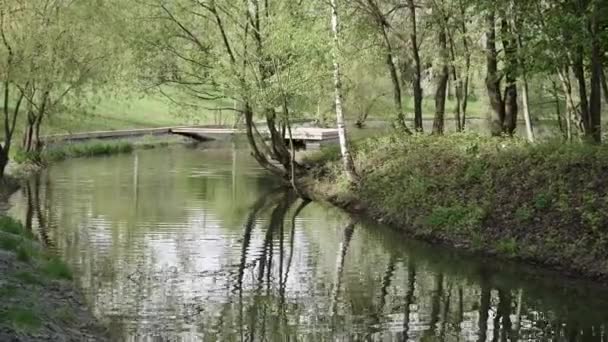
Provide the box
[309,135,608,279]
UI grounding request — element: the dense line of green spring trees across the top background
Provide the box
[0,0,608,179]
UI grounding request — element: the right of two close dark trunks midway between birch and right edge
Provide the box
[501,18,519,136]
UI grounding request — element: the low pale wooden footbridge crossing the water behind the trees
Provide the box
[45,126,338,148]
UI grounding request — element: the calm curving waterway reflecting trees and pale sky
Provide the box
[11,143,608,341]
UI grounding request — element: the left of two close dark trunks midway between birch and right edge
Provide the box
[486,11,505,136]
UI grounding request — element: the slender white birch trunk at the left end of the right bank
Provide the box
[330,0,357,183]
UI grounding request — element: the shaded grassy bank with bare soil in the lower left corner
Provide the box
[0,216,105,341]
